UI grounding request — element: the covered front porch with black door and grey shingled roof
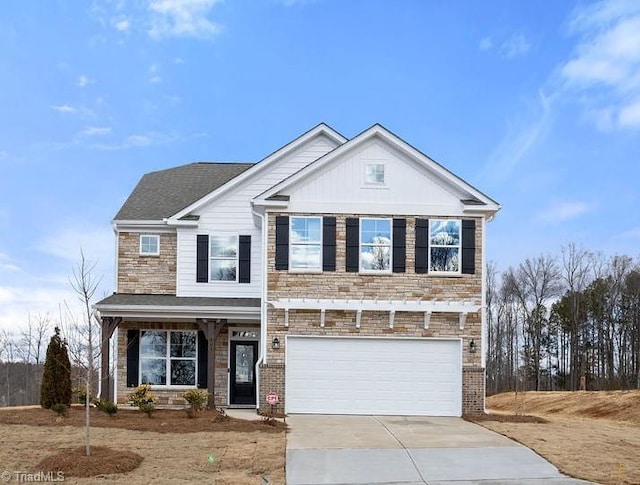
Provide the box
[96,294,261,407]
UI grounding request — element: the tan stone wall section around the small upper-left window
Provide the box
[117,232,177,295]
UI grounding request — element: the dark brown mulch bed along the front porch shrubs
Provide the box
[0,406,287,433]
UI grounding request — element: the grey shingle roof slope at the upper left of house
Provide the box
[115,162,254,221]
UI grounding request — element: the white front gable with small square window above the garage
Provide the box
[254,124,500,216]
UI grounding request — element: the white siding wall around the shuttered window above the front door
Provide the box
[176,135,338,298]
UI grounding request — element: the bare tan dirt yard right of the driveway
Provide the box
[480,391,640,485]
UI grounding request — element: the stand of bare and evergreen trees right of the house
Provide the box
[486,244,640,394]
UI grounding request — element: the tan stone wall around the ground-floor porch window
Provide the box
[117,322,229,406]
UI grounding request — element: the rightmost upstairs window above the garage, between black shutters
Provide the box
[429,219,462,274]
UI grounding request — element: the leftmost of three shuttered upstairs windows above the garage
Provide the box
[289,217,322,271]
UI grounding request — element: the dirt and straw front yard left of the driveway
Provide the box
[0,407,286,485]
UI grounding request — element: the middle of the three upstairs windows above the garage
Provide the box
[360,218,391,272]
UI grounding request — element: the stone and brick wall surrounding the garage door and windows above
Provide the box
[260,214,485,414]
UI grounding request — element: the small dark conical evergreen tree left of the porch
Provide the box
[40,327,71,409]
